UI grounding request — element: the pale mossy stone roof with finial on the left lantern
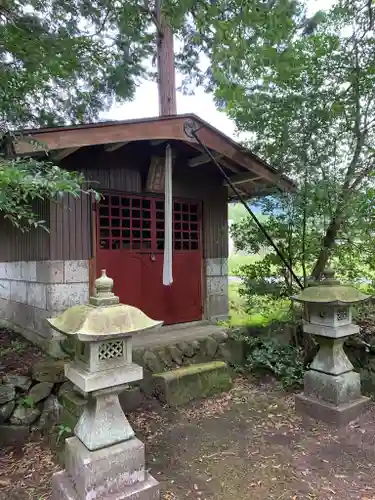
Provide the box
[47,270,163,342]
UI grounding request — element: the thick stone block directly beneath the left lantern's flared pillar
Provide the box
[65,437,147,499]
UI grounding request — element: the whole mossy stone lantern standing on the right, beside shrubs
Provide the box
[292,269,370,425]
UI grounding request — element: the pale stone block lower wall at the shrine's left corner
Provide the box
[0,260,89,356]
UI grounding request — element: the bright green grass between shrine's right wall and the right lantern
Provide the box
[225,283,290,327]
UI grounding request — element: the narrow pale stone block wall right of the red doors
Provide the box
[205,258,229,321]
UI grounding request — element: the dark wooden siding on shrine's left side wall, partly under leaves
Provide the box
[0,201,50,262]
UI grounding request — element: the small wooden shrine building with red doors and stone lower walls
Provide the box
[0,115,293,353]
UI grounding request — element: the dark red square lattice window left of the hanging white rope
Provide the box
[99,196,152,250]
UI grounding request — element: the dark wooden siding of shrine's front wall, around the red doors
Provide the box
[51,144,228,260]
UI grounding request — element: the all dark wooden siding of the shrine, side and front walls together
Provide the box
[0,143,228,262]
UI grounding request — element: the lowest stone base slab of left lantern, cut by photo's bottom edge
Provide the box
[52,471,160,500]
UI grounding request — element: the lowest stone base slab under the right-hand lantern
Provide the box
[295,394,370,426]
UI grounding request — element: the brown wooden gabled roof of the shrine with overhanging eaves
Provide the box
[15,114,295,196]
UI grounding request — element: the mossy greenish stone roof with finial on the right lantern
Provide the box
[292,268,371,306]
